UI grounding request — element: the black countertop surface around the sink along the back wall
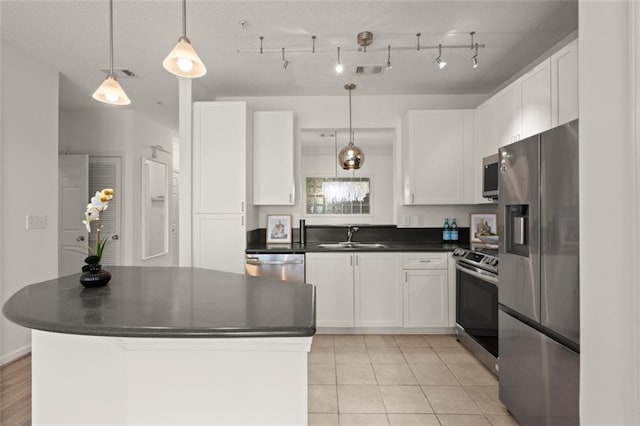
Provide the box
[246,241,469,254]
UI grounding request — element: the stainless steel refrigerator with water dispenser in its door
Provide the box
[498,120,580,426]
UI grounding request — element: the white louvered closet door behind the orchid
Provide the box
[85,156,124,265]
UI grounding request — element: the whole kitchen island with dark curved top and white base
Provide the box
[3,266,315,425]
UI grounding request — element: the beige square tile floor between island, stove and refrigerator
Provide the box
[308,334,518,426]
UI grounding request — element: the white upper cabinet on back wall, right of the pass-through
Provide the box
[402,110,474,205]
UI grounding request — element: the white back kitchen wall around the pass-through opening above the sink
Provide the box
[216,93,495,227]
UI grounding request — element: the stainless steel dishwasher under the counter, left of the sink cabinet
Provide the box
[246,253,304,283]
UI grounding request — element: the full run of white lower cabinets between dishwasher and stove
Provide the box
[306,252,455,329]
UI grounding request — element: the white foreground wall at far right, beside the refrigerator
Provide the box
[579,0,640,425]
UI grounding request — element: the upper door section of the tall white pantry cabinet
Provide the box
[193,102,253,213]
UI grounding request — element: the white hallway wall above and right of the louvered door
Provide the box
[60,108,177,266]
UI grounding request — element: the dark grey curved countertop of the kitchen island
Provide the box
[3,266,316,338]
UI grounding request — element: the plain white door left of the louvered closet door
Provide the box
[58,154,89,277]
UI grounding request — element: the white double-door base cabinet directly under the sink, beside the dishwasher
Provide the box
[305,252,402,327]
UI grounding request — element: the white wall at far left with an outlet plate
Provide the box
[0,41,58,364]
